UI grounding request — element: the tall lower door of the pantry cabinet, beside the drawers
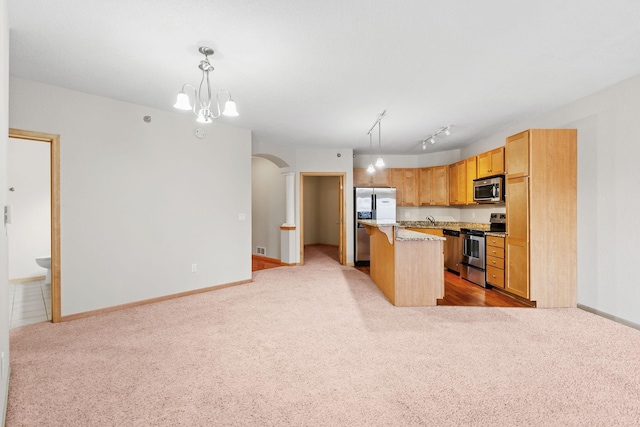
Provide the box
[505,177,529,299]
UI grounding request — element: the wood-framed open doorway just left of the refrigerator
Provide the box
[300,172,347,265]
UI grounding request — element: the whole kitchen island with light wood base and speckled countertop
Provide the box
[360,220,445,307]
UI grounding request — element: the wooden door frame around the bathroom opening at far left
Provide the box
[9,128,62,323]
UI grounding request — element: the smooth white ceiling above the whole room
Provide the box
[8,0,640,154]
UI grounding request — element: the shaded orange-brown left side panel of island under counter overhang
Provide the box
[369,227,397,305]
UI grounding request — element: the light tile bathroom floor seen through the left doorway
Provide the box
[9,279,51,328]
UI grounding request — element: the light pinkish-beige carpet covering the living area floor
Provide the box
[7,247,640,426]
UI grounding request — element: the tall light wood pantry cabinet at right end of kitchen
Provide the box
[505,129,577,307]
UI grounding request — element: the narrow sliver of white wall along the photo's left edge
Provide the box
[0,0,9,425]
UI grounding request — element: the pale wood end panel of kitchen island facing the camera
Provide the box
[394,240,444,307]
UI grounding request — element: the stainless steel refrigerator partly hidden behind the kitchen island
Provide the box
[353,187,396,265]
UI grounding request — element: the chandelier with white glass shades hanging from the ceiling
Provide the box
[173,46,238,123]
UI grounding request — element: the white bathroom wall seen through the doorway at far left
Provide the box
[7,138,51,280]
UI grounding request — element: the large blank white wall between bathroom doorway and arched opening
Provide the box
[10,78,251,316]
